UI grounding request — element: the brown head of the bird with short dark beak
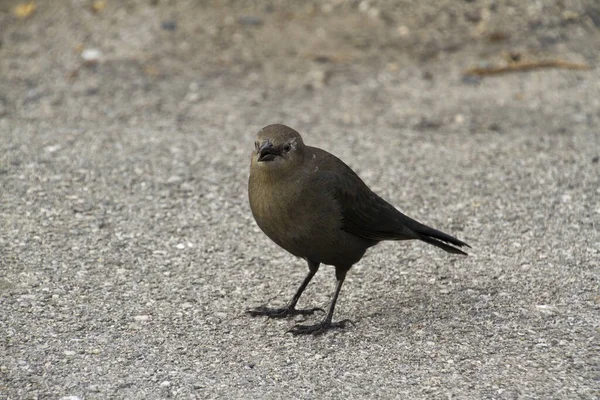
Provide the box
[251,125,305,174]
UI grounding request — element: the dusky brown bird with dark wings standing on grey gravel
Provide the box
[247,124,470,335]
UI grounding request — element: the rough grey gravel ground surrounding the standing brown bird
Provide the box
[0,0,600,399]
